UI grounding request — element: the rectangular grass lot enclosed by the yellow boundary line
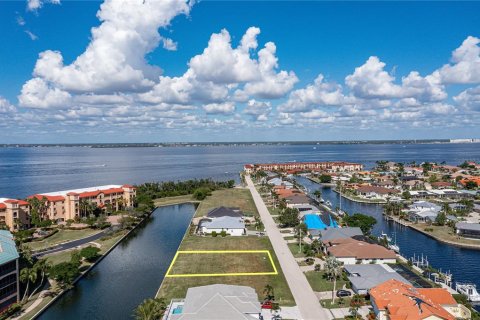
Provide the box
[169,252,275,275]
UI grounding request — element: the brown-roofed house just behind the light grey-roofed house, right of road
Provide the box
[322,238,397,265]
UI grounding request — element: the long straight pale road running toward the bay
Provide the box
[245,176,333,320]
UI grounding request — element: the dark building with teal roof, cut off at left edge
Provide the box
[0,230,20,312]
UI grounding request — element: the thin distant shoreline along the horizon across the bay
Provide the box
[0,139,477,148]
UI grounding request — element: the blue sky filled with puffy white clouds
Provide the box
[0,0,480,143]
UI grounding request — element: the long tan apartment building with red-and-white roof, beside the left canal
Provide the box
[29,185,136,222]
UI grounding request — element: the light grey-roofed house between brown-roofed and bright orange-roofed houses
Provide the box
[344,264,411,295]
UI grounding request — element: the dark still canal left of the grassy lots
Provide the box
[39,204,195,320]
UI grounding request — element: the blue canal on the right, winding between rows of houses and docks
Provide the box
[296,177,480,294]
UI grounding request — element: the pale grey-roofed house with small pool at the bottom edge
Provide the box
[163,284,262,320]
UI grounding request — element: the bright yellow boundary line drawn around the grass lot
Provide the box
[165,250,278,278]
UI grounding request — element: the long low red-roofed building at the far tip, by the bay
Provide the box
[244,161,363,173]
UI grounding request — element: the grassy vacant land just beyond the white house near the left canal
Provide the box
[195,188,258,217]
